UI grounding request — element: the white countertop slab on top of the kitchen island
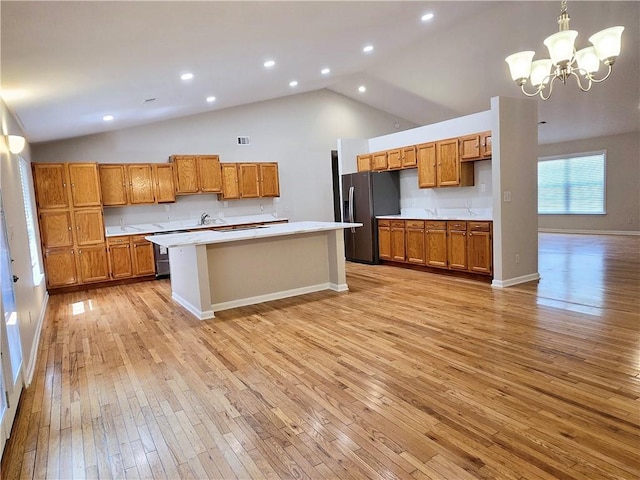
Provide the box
[145,222,362,248]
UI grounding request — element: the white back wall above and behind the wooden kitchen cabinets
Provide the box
[33,90,414,229]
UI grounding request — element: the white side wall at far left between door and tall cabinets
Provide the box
[0,100,48,383]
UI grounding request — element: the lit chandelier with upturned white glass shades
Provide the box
[505,0,624,100]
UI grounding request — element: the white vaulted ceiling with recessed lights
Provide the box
[0,0,640,143]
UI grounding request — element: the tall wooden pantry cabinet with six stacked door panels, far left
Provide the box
[32,163,109,288]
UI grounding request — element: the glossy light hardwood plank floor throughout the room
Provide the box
[2,234,640,480]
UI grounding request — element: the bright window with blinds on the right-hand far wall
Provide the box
[538,151,606,215]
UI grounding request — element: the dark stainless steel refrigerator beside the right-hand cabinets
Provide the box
[342,171,400,263]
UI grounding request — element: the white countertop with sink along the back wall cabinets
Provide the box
[105,213,288,237]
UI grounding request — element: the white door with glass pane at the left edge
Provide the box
[0,191,23,449]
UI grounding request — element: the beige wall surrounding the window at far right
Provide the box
[538,127,640,233]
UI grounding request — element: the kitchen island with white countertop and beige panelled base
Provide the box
[146,222,361,320]
